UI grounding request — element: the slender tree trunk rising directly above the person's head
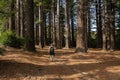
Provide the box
[51,0,56,46]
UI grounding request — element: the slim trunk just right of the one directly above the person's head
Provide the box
[56,0,62,49]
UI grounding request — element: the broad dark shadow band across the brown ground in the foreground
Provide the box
[0,57,120,78]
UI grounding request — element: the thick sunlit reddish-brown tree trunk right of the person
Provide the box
[76,0,87,52]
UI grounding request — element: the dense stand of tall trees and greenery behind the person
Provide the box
[0,0,120,52]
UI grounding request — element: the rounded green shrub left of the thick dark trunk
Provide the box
[0,31,24,48]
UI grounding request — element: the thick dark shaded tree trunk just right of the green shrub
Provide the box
[24,0,35,51]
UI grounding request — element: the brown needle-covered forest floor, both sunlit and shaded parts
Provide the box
[0,48,120,80]
